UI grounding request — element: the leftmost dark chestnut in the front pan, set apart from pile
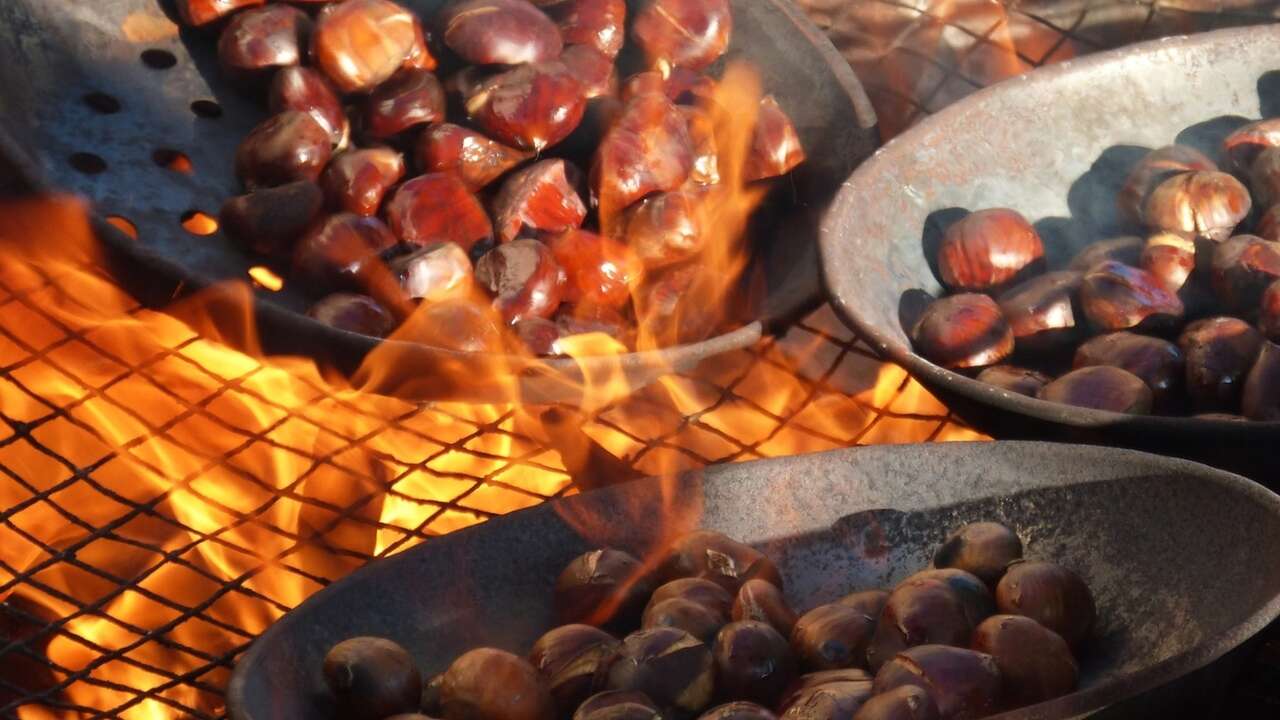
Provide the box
[324,637,422,720]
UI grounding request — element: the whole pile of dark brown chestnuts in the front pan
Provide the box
[324,523,1096,720]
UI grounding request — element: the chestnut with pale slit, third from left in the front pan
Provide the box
[529,625,618,716]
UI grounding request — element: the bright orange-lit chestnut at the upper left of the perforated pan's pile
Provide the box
[311,0,422,92]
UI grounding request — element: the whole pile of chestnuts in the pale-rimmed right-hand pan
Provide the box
[911,118,1280,420]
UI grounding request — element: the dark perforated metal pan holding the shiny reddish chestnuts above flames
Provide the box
[0,0,878,402]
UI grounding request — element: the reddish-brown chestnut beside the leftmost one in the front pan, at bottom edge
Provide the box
[440,647,556,720]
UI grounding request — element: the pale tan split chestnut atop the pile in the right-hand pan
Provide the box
[1142,170,1253,242]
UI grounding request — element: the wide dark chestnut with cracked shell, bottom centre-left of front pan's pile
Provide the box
[600,628,716,716]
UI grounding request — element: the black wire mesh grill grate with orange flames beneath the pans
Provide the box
[0,0,1275,720]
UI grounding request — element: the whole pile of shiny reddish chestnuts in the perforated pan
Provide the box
[178,0,804,355]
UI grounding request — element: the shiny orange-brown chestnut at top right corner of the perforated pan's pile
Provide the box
[631,0,733,70]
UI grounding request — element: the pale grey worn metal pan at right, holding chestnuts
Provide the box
[820,26,1280,482]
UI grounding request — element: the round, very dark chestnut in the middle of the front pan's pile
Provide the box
[712,620,799,707]
